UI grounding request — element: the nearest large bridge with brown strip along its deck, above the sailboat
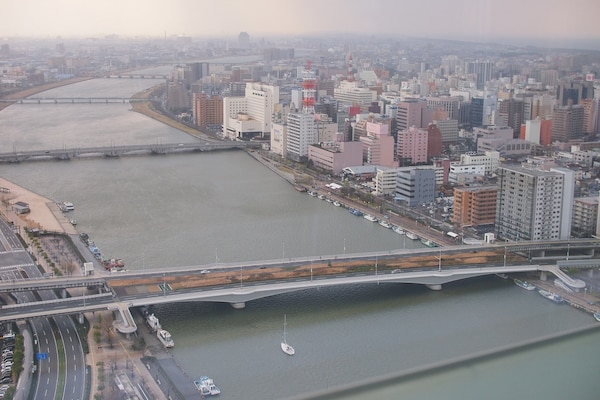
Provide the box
[0,239,600,333]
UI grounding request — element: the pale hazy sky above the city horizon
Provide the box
[0,0,600,42]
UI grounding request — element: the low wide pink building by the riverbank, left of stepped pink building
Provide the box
[308,142,362,174]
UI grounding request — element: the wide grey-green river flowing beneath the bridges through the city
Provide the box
[0,70,600,400]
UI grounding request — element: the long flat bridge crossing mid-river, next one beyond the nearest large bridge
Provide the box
[0,141,261,163]
